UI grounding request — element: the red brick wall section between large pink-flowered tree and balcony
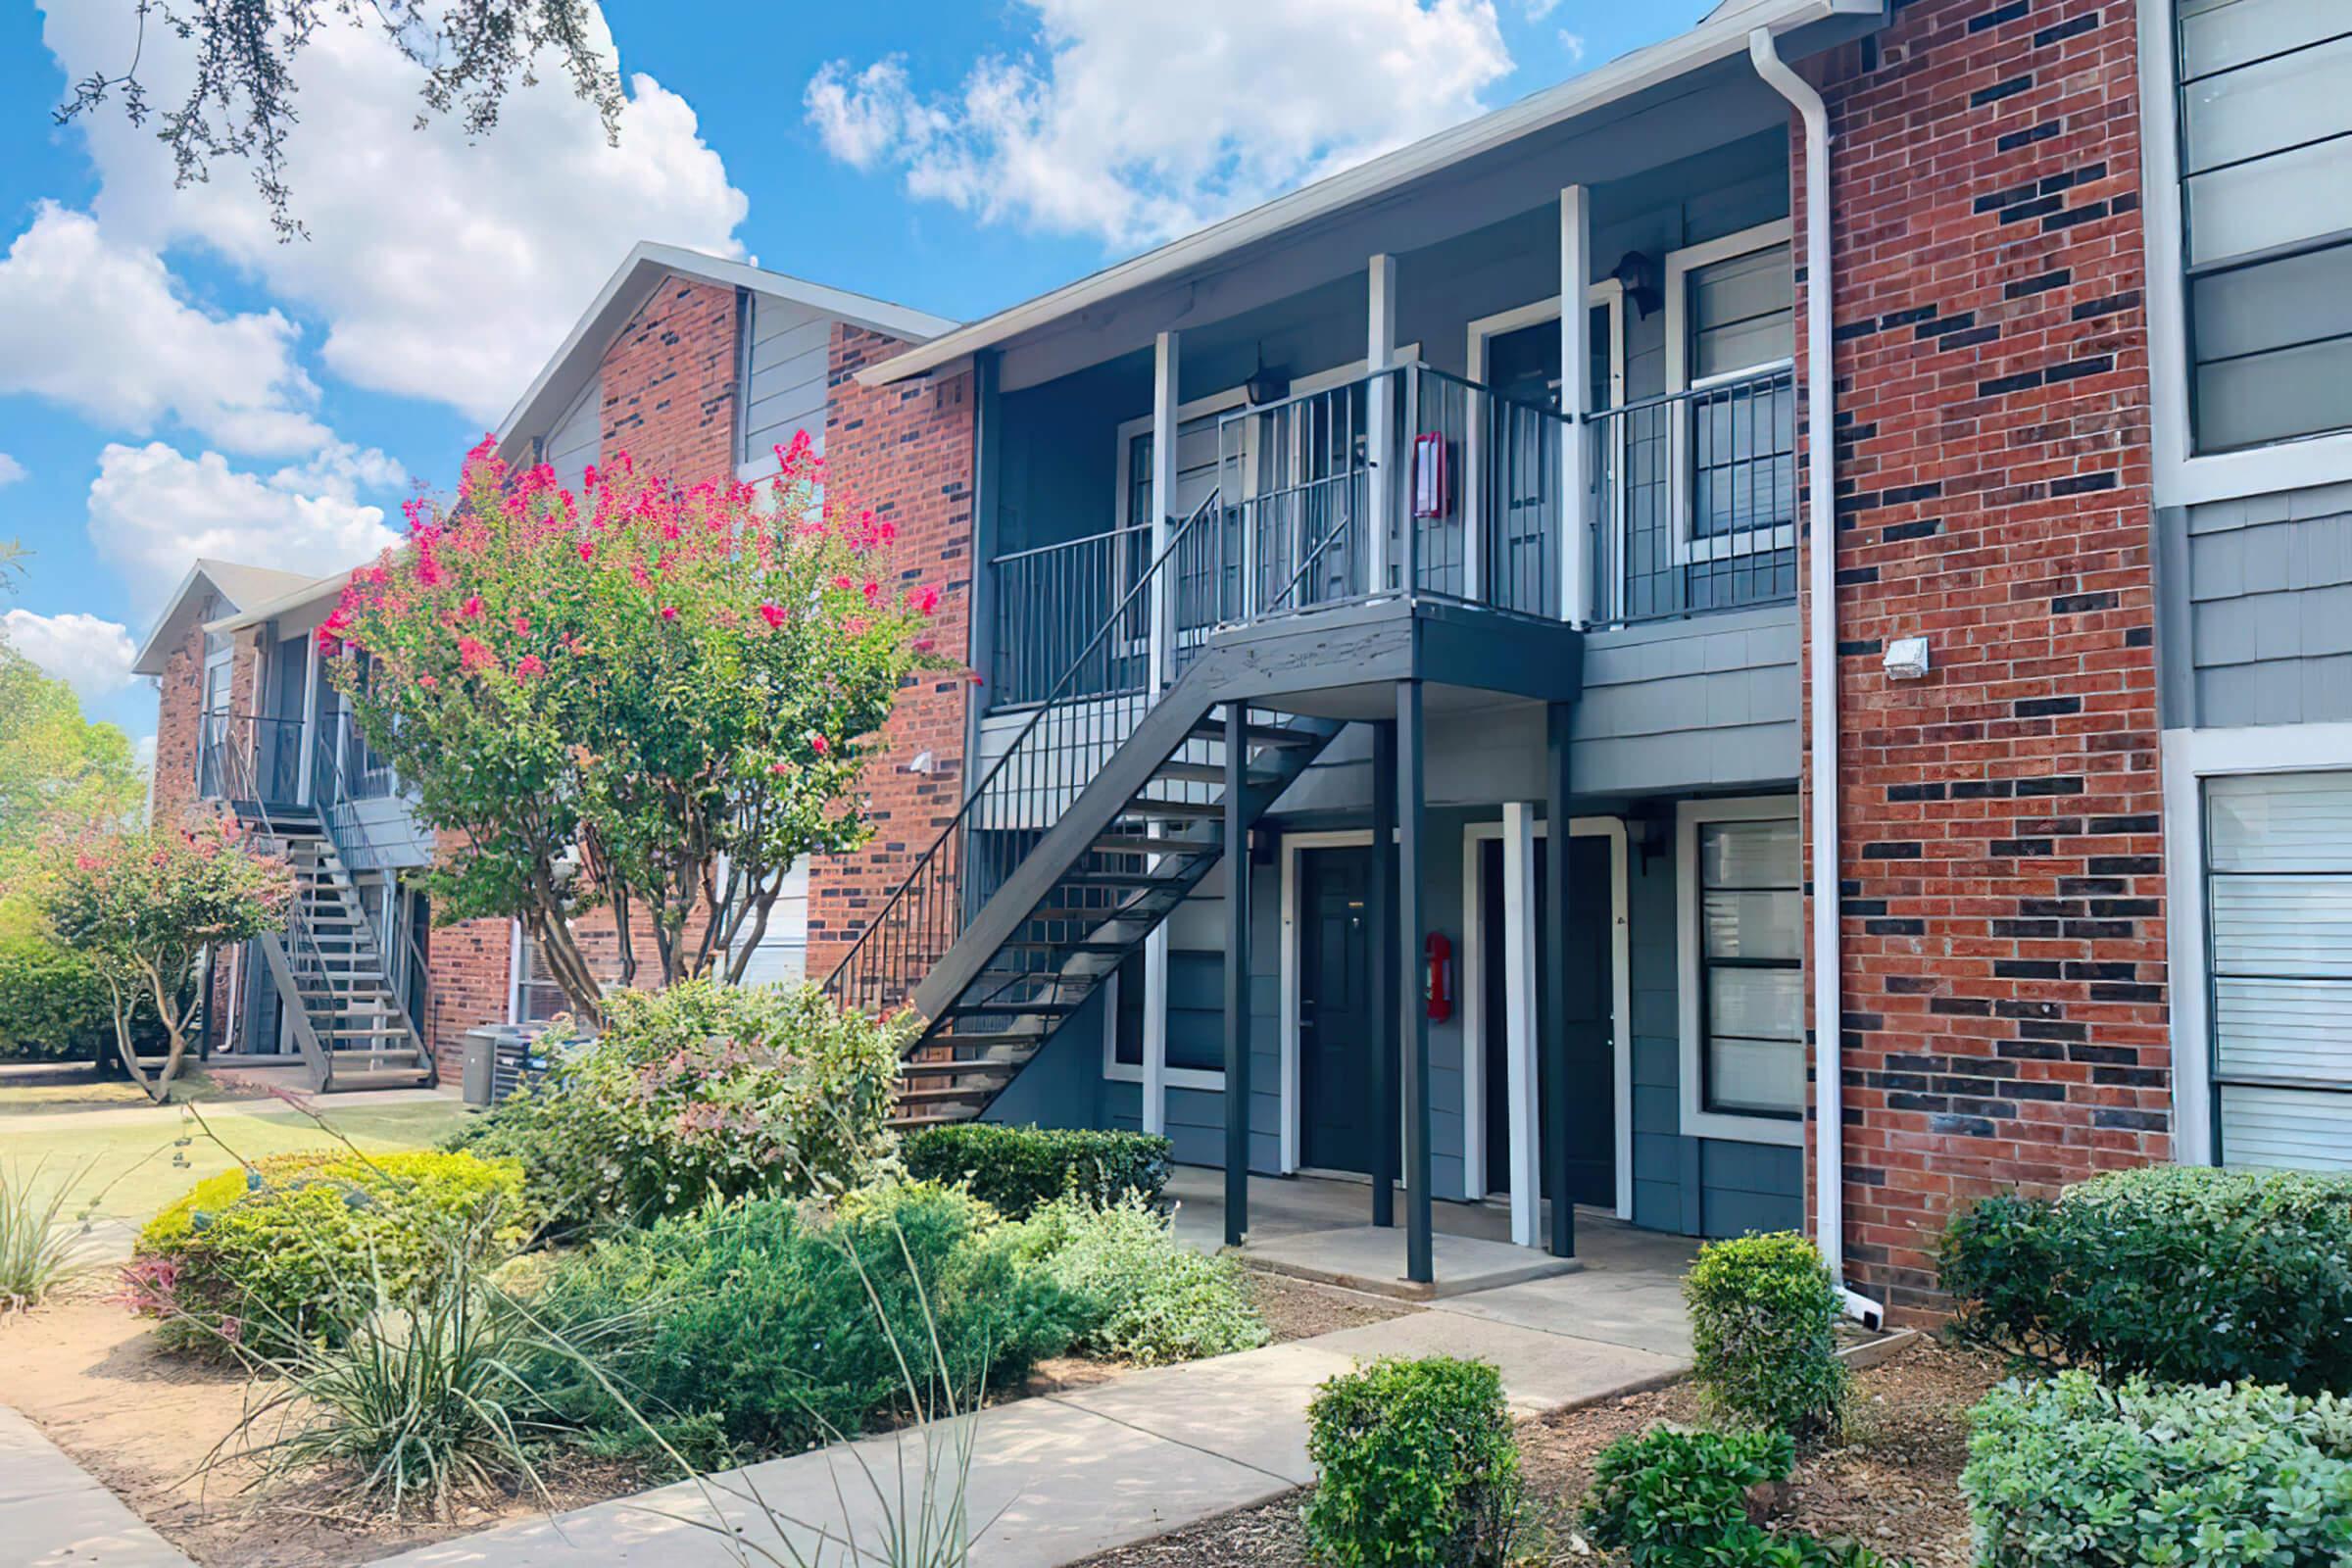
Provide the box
[809,324,974,980]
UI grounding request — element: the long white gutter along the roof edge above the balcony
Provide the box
[858,0,1886,385]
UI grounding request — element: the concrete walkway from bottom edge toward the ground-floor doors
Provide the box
[383,1183,1691,1568]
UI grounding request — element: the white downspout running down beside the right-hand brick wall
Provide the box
[1747,28,1851,1296]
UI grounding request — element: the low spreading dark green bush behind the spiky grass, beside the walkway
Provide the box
[527,1185,1077,1452]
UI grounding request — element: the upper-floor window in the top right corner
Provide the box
[2176,0,2352,452]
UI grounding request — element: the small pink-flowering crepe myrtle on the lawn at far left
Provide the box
[35,818,294,1101]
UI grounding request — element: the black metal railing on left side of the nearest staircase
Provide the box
[825,491,1218,1029]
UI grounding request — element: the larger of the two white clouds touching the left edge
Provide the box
[0,202,327,454]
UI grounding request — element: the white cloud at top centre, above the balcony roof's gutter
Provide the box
[805,0,1510,244]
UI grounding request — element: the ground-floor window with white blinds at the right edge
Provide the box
[2206,773,2352,1171]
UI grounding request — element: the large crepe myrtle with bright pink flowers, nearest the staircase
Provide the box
[319,432,943,1025]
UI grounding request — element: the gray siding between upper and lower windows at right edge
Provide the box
[2159,484,2352,726]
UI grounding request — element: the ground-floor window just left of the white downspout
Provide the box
[1698,815,1804,1116]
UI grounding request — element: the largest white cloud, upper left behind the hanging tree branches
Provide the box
[42,2,746,425]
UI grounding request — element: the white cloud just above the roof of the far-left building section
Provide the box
[89,442,395,612]
